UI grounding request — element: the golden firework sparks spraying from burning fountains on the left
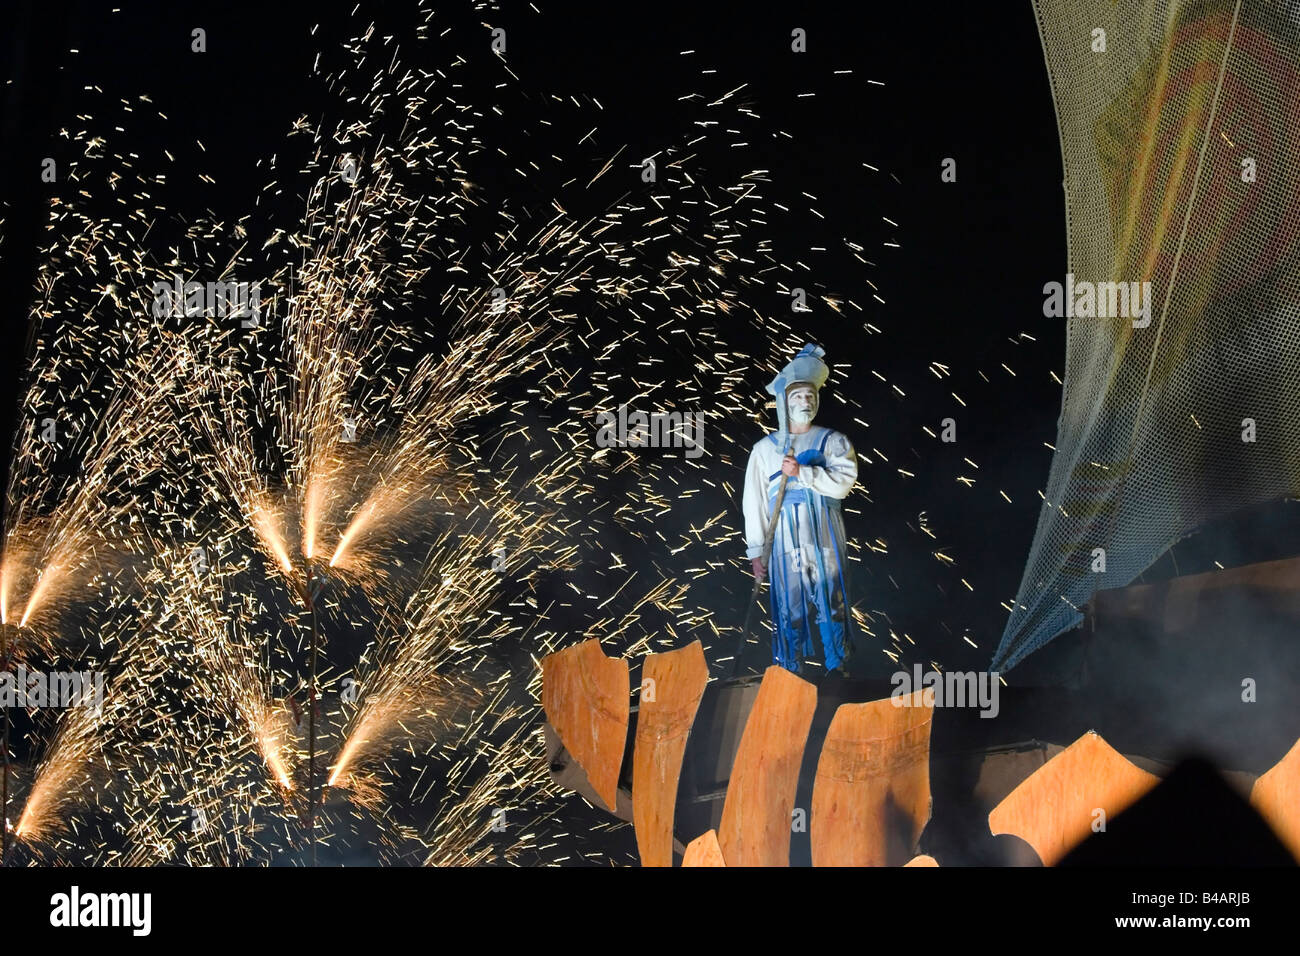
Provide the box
[0,0,1055,864]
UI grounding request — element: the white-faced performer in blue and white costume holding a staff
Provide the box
[744,345,858,676]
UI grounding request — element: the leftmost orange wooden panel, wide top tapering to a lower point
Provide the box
[542,637,629,810]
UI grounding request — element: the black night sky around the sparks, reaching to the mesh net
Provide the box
[0,4,1065,681]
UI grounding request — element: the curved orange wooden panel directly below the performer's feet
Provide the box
[718,665,816,866]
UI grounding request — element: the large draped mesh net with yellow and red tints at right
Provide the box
[992,0,1300,671]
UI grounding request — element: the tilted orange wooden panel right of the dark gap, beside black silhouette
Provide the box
[988,731,1157,866]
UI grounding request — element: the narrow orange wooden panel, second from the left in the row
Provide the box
[632,641,709,866]
